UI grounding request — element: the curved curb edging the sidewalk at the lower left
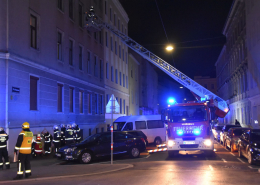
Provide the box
[0,164,134,184]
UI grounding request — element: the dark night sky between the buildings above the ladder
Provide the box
[120,0,233,79]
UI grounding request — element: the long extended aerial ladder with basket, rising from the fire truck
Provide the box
[85,7,229,118]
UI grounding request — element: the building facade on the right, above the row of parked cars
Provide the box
[215,0,260,128]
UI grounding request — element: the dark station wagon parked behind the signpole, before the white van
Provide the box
[56,132,146,163]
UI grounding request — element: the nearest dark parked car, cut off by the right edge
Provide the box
[238,129,260,164]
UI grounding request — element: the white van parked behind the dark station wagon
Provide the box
[113,115,166,145]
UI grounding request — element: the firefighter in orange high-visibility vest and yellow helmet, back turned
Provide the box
[14,122,33,180]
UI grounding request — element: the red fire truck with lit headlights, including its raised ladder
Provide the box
[85,7,229,156]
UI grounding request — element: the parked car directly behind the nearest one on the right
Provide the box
[224,127,250,152]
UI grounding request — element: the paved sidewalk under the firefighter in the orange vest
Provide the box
[0,158,133,184]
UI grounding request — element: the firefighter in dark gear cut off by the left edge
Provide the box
[0,127,10,170]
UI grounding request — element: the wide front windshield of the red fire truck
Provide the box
[167,105,207,123]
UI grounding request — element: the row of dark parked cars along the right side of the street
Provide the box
[212,125,260,164]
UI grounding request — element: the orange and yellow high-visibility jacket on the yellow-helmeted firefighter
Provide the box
[14,129,33,154]
